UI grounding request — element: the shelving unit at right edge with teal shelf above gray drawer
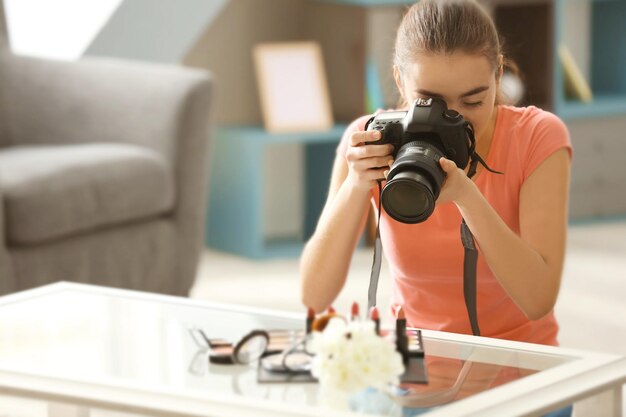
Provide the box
[553,0,626,221]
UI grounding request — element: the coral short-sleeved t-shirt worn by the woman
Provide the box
[337,106,572,345]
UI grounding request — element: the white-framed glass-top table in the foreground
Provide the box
[0,283,626,417]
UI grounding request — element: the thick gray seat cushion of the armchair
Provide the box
[0,143,175,245]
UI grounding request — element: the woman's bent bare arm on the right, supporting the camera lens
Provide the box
[441,149,570,320]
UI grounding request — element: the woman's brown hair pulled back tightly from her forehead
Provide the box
[394,0,519,102]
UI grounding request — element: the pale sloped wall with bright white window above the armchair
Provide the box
[0,0,228,63]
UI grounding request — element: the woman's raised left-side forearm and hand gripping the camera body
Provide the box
[300,132,393,311]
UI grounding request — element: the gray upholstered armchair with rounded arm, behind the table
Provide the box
[0,48,212,295]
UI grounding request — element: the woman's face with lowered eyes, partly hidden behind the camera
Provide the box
[394,52,499,140]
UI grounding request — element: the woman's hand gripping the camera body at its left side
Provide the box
[346,130,394,191]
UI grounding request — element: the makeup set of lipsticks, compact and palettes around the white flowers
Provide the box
[190,302,427,383]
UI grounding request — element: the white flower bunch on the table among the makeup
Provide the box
[310,318,404,393]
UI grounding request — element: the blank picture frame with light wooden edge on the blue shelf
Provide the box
[253,41,333,133]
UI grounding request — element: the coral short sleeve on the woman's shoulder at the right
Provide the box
[523,111,572,178]
